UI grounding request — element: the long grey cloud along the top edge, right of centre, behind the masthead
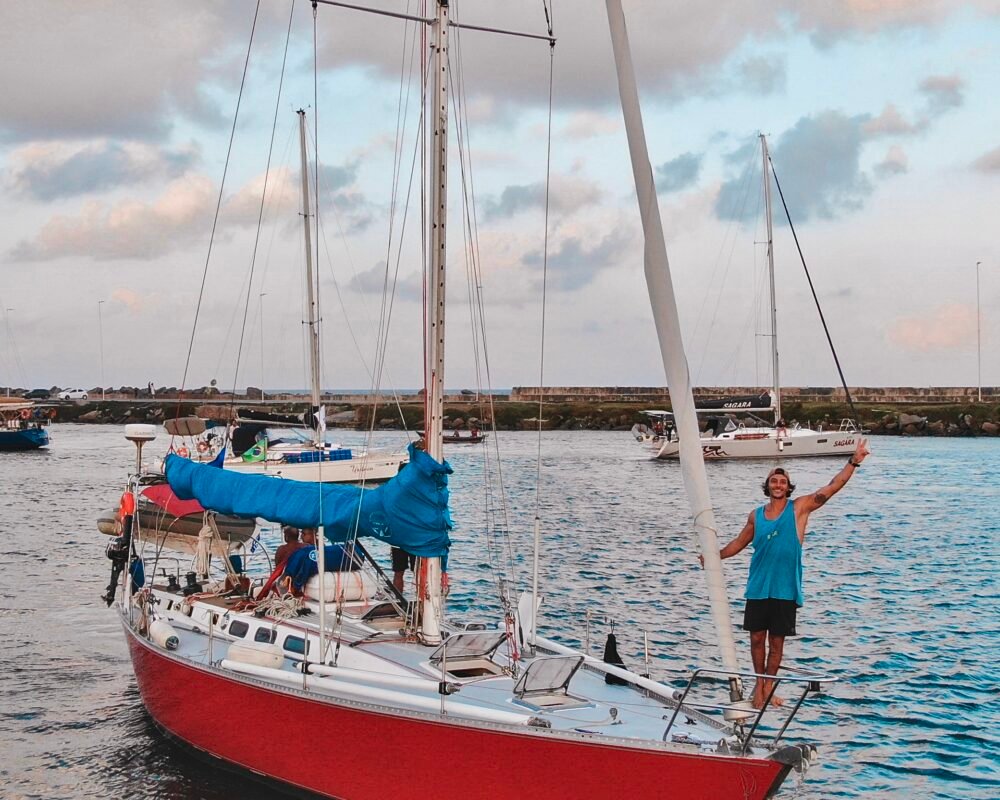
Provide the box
[310,0,995,112]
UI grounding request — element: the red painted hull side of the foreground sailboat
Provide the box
[126,628,789,800]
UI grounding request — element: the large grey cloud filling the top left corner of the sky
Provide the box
[0,0,287,142]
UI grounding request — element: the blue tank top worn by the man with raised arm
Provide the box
[746,500,805,606]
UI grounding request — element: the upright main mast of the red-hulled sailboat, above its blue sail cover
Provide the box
[418,0,449,645]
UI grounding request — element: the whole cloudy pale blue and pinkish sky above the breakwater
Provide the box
[0,0,1000,389]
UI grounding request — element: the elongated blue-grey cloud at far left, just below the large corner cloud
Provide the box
[7,139,198,202]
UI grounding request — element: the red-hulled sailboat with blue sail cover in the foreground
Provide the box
[108,0,828,800]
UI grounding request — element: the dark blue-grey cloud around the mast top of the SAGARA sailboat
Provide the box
[715,111,872,224]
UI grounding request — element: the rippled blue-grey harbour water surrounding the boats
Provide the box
[0,424,1000,800]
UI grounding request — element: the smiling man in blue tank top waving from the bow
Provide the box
[712,439,868,708]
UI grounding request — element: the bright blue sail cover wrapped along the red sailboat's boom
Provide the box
[166,444,452,558]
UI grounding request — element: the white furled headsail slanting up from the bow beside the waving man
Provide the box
[606,0,742,688]
